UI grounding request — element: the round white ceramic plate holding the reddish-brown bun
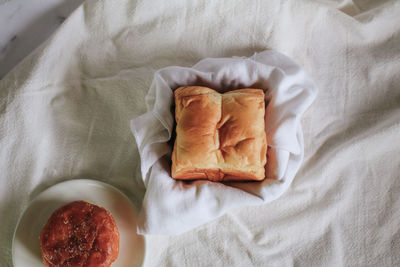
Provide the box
[12,179,144,267]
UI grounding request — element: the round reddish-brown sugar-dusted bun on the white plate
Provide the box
[40,201,119,267]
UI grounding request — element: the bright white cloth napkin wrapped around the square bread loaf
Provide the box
[131,50,317,235]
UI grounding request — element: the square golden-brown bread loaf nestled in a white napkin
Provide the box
[171,86,267,181]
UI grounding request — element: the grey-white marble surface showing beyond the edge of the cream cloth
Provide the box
[0,0,84,79]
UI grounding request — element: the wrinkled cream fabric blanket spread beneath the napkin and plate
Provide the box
[0,0,400,266]
